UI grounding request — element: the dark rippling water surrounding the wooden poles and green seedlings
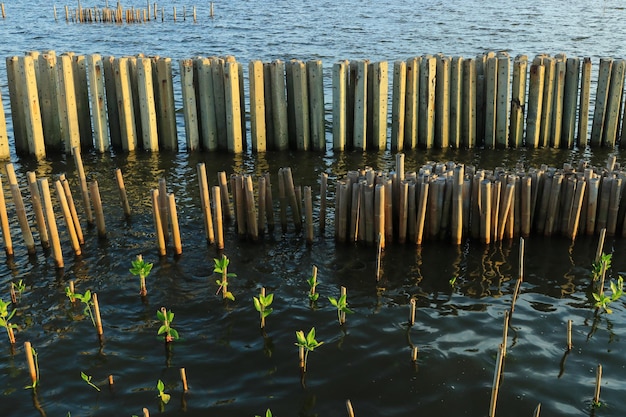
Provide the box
[0,0,626,417]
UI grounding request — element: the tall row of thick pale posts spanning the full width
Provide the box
[7,51,626,158]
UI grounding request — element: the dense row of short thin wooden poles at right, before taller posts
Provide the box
[336,154,626,247]
